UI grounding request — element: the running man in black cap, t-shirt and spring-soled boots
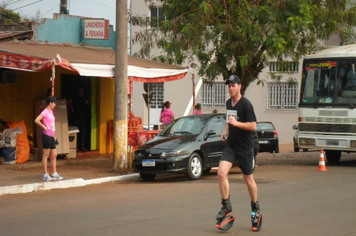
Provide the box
[216,75,262,231]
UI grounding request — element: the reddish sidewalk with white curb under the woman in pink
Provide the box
[0,152,139,195]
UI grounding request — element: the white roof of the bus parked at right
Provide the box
[304,44,356,59]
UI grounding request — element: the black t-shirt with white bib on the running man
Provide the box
[226,97,256,151]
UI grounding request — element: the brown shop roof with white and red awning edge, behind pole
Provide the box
[0,42,189,80]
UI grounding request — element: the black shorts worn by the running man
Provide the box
[220,144,256,175]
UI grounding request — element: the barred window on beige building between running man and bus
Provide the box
[268,82,298,109]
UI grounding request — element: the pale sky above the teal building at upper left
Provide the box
[0,0,116,29]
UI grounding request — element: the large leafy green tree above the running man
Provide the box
[132,0,356,93]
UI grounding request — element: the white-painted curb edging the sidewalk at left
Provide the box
[0,173,139,196]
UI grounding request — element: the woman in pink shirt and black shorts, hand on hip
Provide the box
[35,96,63,181]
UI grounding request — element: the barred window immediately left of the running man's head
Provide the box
[202,82,226,107]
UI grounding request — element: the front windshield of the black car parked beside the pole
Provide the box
[159,116,208,136]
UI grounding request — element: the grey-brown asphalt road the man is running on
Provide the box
[0,152,356,236]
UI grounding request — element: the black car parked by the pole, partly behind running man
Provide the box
[133,114,226,180]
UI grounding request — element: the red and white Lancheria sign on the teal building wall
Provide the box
[84,19,109,39]
